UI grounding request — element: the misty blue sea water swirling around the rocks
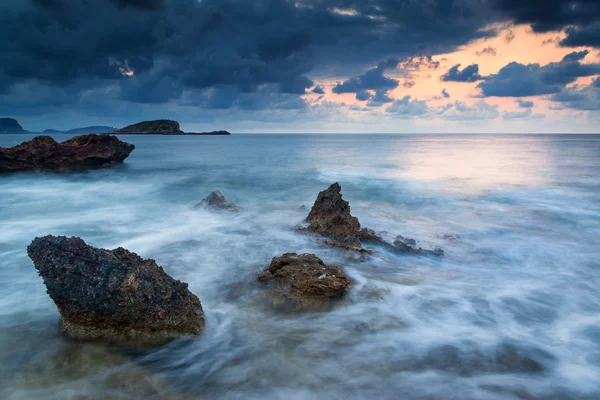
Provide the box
[0,135,600,400]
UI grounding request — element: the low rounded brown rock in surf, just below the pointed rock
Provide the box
[258,253,351,306]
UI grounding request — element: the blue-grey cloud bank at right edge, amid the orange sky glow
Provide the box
[477,50,600,97]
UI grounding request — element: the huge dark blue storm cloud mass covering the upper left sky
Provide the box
[0,0,495,112]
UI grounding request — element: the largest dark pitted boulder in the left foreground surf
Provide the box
[27,236,204,343]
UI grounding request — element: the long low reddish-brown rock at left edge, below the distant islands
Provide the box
[0,134,135,172]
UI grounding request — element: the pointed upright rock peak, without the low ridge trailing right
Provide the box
[306,182,378,247]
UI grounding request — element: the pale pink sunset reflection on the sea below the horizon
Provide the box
[396,136,553,191]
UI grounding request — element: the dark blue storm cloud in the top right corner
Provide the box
[491,0,600,46]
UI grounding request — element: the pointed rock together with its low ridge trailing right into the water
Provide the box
[306,182,444,256]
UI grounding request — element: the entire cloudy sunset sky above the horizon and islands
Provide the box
[0,0,600,133]
